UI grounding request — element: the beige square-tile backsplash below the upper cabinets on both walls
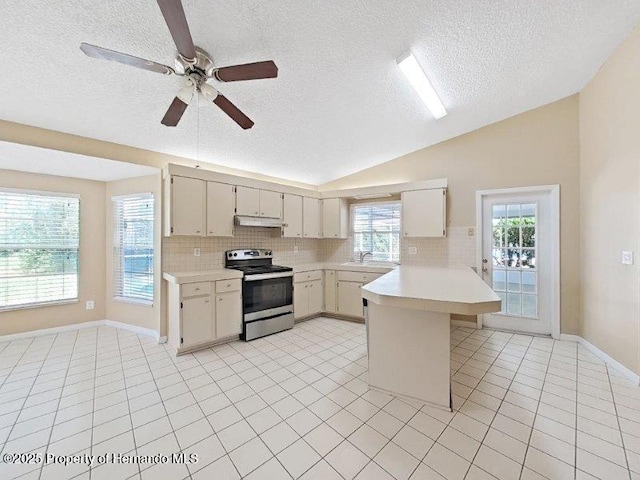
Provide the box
[162,227,476,271]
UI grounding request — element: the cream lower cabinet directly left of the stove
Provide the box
[168,278,242,353]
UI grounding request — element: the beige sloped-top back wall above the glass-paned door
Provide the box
[320,95,580,333]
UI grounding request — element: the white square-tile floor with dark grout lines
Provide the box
[0,319,640,480]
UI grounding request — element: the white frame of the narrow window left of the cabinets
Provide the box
[111,192,157,307]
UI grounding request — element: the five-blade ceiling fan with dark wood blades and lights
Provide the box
[80,0,278,130]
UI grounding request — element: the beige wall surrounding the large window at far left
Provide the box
[0,170,106,335]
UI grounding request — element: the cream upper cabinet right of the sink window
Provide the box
[402,188,447,237]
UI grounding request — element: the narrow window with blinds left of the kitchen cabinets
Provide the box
[112,193,154,305]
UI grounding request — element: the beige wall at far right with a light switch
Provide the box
[580,27,640,374]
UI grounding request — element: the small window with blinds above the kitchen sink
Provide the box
[351,202,400,262]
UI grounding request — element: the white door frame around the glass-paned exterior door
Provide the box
[476,185,560,339]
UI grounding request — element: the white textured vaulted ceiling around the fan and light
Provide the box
[0,0,640,184]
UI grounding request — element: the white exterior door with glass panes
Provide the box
[482,193,552,334]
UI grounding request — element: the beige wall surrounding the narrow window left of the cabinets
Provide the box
[105,172,163,332]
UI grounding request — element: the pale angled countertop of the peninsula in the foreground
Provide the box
[362,265,500,315]
